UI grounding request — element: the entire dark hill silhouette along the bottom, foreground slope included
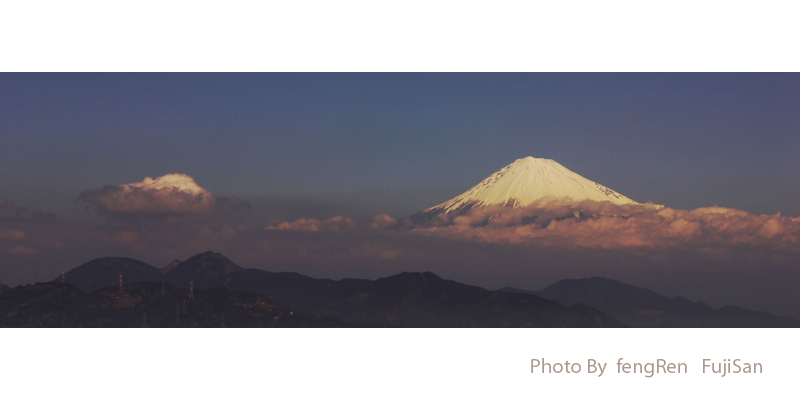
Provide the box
[0,251,800,327]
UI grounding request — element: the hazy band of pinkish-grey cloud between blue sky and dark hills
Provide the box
[0,192,800,315]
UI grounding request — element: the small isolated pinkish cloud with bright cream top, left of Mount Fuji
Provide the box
[81,174,216,215]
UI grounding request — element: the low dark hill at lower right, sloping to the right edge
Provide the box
[500,277,800,328]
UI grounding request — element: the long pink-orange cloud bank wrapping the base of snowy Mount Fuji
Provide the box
[412,201,800,250]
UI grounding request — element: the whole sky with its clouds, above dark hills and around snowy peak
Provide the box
[0,73,800,316]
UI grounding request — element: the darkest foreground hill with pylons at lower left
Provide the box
[0,282,358,328]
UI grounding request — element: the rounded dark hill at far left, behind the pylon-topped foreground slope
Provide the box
[51,257,163,292]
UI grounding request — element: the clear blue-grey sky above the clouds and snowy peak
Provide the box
[0,73,800,217]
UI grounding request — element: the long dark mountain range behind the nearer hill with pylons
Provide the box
[47,251,800,327]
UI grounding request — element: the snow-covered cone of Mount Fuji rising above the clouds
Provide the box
[412,157,639,219]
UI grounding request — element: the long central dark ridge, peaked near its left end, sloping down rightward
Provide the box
[53,251,624,327]
